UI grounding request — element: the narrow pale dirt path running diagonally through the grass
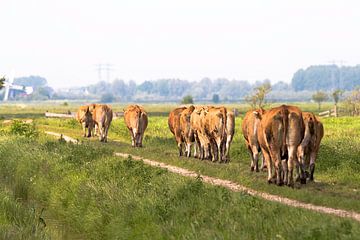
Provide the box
[45,132,360,222]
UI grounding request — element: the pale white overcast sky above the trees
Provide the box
[0,0,360,88]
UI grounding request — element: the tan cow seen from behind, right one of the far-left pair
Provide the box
[90,104,113,142]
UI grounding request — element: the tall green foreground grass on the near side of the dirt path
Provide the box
[0,135,360,239]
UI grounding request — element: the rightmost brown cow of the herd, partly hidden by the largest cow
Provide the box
[297,112,324,181]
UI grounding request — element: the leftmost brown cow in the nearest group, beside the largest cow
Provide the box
[241,108,265,172]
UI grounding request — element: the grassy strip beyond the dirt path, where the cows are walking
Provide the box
[31,113,360,212]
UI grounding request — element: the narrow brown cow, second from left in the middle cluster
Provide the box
[180,105,195,157]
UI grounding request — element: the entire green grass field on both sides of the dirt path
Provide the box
[0,102,360,239]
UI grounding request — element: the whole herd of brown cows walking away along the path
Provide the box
[76,104,324,186]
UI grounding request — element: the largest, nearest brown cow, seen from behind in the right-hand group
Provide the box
[258,105,306,186]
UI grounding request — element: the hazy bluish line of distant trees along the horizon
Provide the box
[0,65,360,102]
